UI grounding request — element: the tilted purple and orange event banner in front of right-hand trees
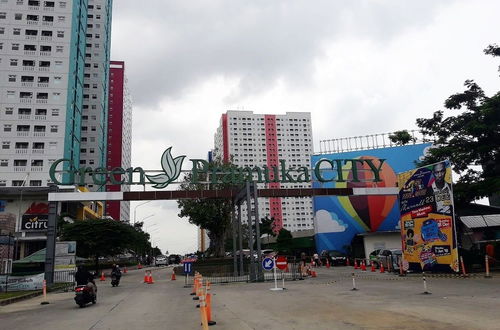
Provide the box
[398,161,459,272]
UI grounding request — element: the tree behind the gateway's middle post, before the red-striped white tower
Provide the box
[177,161,234,257]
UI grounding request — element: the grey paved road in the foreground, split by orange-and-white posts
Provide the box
[0,267,500,330]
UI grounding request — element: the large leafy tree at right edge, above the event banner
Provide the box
[394,45,500,204]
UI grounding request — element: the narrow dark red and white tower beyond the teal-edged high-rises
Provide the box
[106,61,132,221]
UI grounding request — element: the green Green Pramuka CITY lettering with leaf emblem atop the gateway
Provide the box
[49,147,385,189]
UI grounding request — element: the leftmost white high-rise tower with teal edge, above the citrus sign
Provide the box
[0,0,87,187]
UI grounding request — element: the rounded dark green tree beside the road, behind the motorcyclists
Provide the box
[62,219,145,271]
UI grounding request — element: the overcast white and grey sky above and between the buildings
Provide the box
[111,0,500,253]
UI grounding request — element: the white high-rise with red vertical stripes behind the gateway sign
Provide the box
[213,110,314,231]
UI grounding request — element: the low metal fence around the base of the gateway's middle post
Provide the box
[175,257,303,285]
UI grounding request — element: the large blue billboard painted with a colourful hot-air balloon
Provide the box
[312,143,431,252]
